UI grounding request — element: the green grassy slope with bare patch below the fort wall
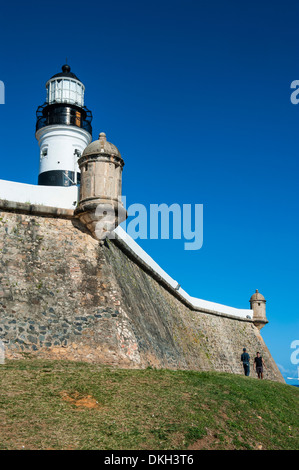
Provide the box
[0,359,299,450]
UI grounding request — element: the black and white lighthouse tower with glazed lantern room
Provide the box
[35,64,92,187]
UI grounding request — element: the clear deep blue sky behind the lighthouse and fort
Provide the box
[0,0,299,383]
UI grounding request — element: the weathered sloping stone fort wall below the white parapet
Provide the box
[0,211,283,382]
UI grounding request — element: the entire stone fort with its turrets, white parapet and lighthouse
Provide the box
[0,66,284,382]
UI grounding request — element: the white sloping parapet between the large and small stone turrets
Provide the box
[114,225,253,320]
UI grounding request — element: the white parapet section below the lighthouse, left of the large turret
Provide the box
[0,180,78,209]
